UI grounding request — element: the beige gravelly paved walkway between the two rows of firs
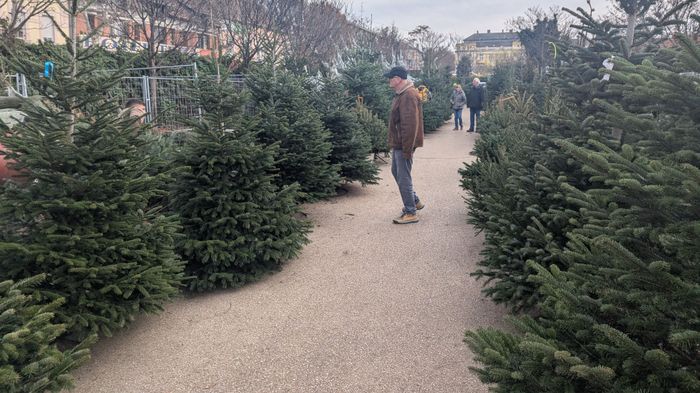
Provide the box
[75,123,505,393]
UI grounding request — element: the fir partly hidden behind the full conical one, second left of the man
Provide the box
[246,66,340,200]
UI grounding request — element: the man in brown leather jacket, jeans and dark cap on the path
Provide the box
[384,67,425,224]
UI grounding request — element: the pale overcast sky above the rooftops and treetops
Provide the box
[346,0,609,38]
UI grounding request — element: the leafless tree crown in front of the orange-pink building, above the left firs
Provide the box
[218,0,294,70]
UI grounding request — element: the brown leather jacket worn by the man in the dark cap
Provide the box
[389,83,423,159]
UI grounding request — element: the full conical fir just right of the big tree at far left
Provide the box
[172,81,309,291]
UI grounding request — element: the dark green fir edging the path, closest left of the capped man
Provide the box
[314,78,379,185]
